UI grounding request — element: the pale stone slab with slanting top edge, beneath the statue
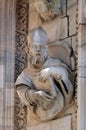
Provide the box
[26,113,76,130]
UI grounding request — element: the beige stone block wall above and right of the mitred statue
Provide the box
[28,0,78,100]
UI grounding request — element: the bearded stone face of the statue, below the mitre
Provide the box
[29,42,48,68]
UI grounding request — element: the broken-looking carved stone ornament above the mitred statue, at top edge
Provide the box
[29,0,62,21]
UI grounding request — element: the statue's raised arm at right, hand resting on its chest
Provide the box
[39,66,73,103]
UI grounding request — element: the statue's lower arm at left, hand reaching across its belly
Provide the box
[16,84,53,109]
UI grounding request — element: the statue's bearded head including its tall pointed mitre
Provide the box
[27,27,48,68]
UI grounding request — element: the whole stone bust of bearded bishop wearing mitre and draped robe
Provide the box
[15,27,74,122]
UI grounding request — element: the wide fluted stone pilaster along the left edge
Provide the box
[0,0,15,130]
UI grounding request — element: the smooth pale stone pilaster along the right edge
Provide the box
[78,0,86,130]
